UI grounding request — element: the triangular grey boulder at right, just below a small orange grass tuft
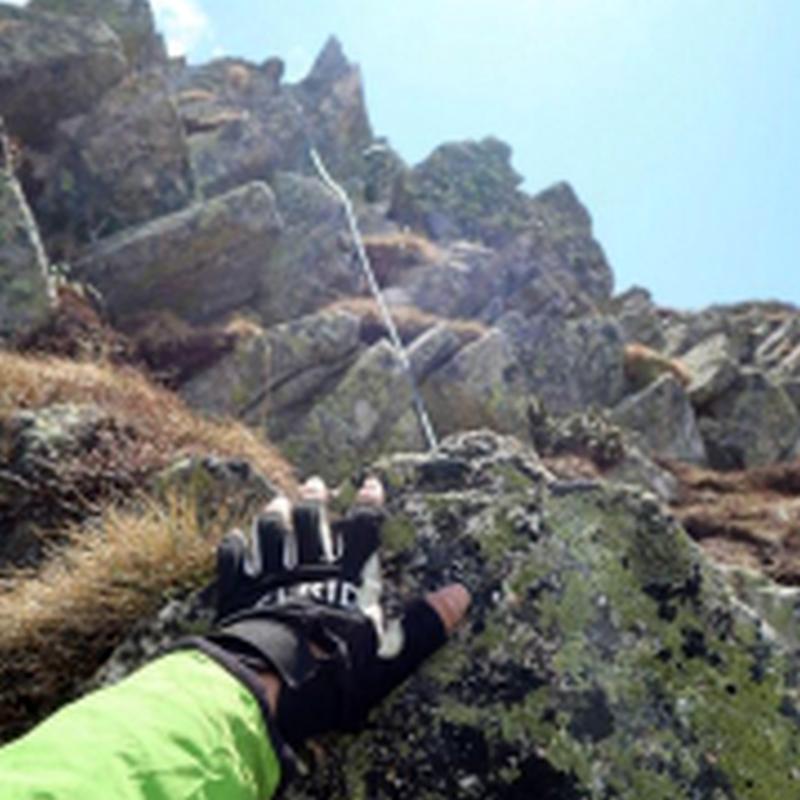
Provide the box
[611,375,706,464]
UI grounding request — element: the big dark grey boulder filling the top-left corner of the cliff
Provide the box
[0,5,128,144]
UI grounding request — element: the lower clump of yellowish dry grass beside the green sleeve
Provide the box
[0,496,234,740]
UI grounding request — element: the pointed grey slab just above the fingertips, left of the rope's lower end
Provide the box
[279,340,424,482]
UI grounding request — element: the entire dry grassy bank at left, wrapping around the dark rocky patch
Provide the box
[0,351,296,740]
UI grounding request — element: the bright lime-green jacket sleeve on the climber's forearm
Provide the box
[0,651,280,800]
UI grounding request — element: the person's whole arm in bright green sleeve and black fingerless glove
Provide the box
[0,476,469,800]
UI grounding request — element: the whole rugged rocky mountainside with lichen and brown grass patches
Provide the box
[0,0,800,800]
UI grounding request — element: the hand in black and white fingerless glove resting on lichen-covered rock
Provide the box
[188,479,469,760]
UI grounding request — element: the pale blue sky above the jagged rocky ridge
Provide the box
[125,0,800,308]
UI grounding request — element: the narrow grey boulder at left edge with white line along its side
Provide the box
[0,122,54,340]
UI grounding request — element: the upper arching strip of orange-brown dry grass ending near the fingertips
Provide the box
[0,351,296,493]
